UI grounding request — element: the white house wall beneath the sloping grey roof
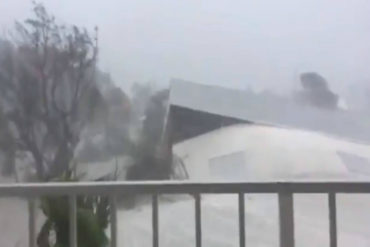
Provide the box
[173,124,370,181]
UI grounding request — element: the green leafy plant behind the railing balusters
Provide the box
[37,173,110,247]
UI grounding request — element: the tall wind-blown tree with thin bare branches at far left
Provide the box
[0,3,101,181]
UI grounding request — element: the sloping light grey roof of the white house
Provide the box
[170,79,370,143]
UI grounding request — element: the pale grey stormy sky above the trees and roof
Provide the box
[0,0,370,92]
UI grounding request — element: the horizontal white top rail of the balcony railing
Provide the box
[0,181,370,197]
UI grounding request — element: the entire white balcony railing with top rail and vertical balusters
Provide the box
[0,182,370,247]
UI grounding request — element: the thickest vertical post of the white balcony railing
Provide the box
[279,192,294,247]
